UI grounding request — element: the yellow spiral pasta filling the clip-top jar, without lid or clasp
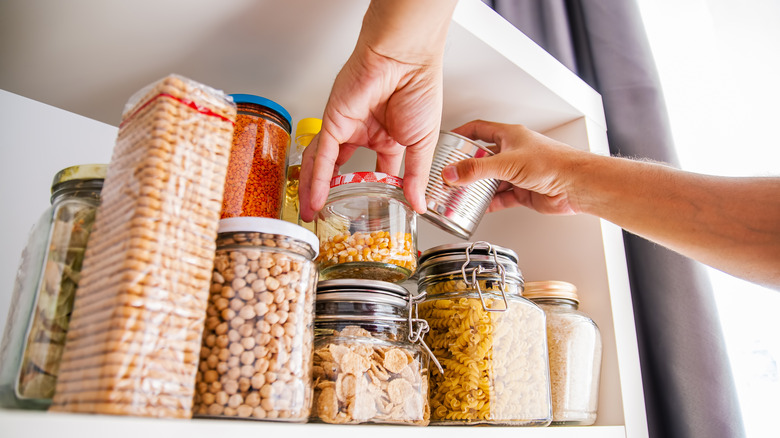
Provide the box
[419,281,551,426]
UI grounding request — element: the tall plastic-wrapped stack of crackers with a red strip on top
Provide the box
[51,76,236,418]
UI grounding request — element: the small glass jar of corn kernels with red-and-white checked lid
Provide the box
[317,172,417,283]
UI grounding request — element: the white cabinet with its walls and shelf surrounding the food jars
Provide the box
[0,0,647,438]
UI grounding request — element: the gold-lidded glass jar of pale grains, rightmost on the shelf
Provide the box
[524,281,601,425]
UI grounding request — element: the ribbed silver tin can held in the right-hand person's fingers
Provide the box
[423,131,499,239]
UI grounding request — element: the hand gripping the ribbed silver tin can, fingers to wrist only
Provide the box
[442,120,592,214]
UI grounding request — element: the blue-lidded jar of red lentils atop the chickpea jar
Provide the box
[221,94,292,219]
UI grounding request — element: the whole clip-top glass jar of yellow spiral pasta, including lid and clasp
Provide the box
[418,242,552,426]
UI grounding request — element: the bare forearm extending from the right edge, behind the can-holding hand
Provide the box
[572,157,780,288]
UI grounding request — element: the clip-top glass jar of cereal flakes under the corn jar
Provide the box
[311,279,430,426]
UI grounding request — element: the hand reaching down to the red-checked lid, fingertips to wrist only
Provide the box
[299,45,442,221]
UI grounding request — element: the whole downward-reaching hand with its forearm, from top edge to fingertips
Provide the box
[298,0,457,221]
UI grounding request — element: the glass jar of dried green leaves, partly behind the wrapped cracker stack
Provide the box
[0,164,106,409]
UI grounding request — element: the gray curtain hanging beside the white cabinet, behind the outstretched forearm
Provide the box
[485,0,745,438]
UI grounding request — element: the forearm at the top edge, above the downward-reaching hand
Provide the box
[358,0,457,64]
